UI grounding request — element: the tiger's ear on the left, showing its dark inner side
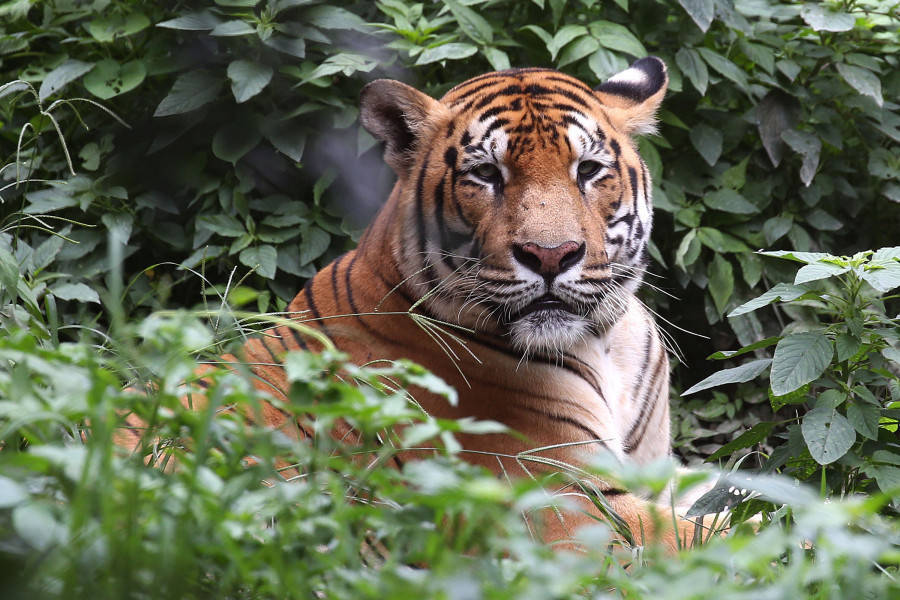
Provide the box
[359,79,448,176]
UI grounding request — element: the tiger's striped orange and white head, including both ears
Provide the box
[361,57,668,354]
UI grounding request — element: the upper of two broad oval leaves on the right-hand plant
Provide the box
[768,330,834,396]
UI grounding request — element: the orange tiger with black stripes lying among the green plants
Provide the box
[126,57,694,549]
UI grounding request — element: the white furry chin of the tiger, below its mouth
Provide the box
[508,310,593,357]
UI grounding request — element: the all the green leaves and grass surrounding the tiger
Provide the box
[0,0,900,598]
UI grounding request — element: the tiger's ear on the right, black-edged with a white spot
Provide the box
[594,56,669,134]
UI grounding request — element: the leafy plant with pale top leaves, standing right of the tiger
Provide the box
[684,247,900,502]
